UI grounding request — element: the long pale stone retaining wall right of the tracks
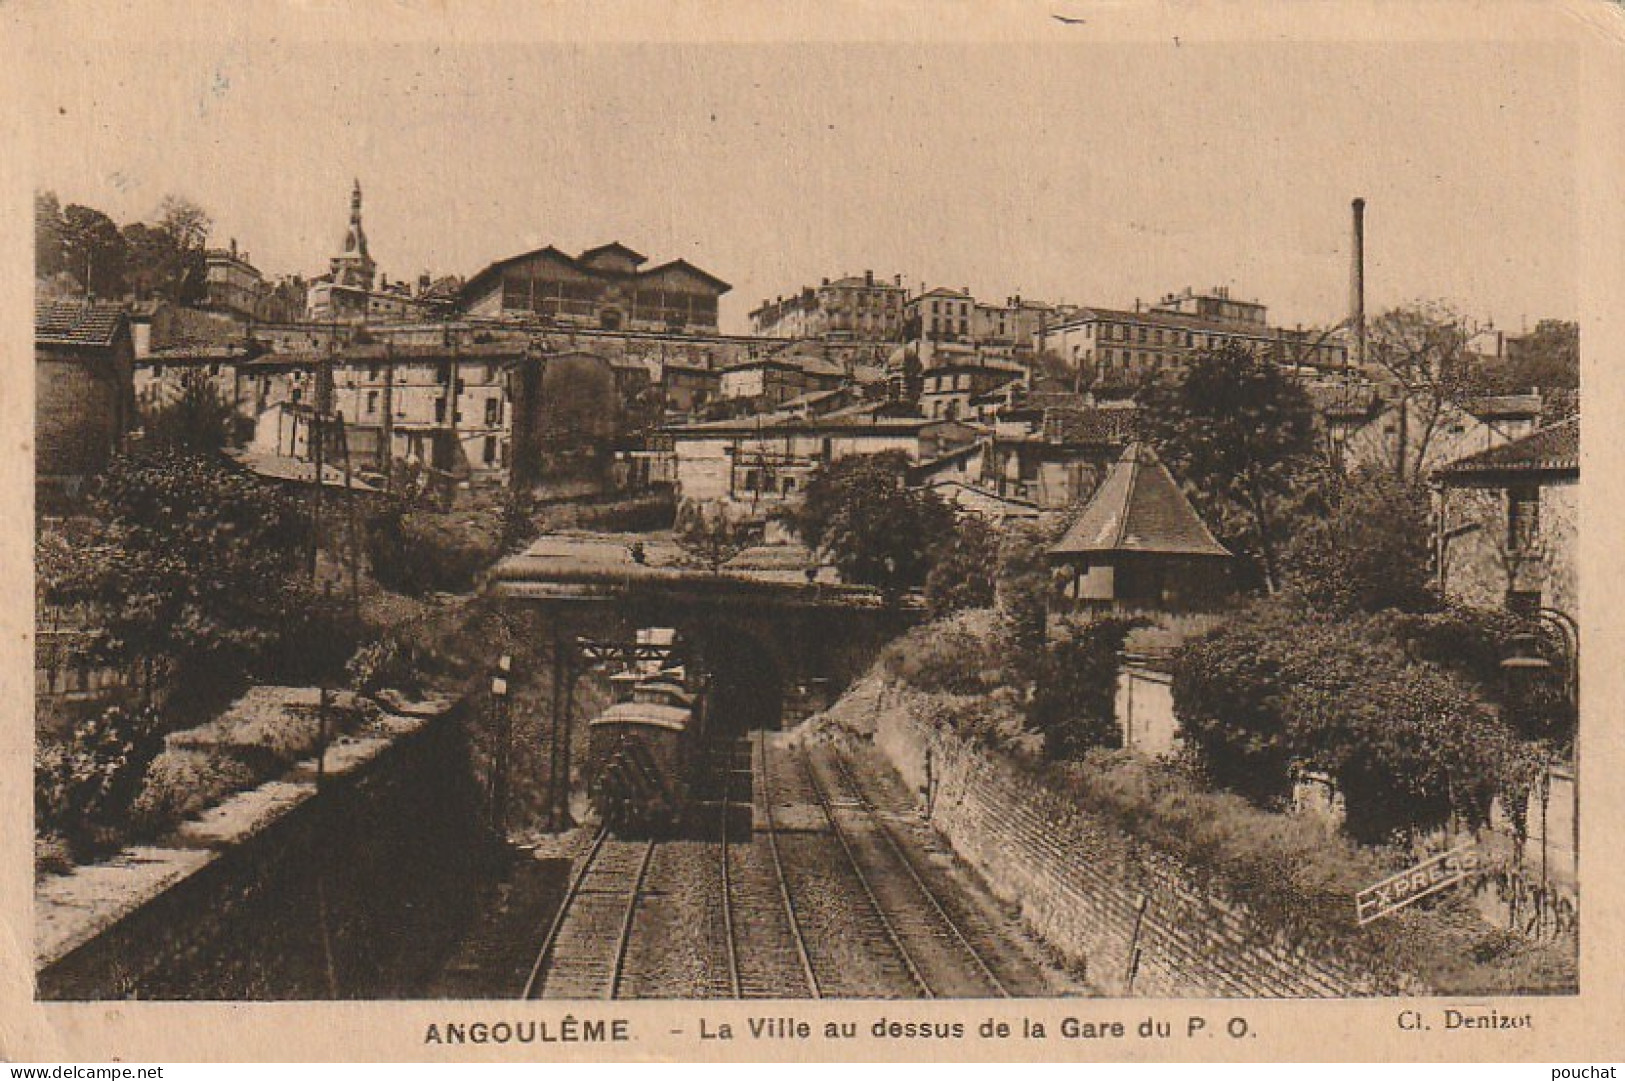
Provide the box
[874,689,1422,998]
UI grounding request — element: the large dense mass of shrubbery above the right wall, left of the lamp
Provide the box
[1173,601,1531,842]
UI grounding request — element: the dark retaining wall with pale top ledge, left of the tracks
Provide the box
[36,698,488,1000]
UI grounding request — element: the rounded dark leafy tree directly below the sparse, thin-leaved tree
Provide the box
[1282,467,1437,611]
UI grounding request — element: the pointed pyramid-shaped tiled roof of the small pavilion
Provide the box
[1050,442,1230,556]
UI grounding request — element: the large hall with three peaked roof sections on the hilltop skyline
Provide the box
[462,244,733,333]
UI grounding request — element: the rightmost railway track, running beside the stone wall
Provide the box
[801,748,1009,998]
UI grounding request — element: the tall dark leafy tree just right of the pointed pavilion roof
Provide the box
[1136,343,1315,593]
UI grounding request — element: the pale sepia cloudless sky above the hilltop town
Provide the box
[15,5,1583,332]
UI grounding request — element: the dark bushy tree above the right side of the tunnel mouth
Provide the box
[788,450,954,598]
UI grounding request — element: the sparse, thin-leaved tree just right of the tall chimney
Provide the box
[1367,301,1490,481]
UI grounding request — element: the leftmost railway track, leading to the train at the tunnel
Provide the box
[522,829,655,1000]
